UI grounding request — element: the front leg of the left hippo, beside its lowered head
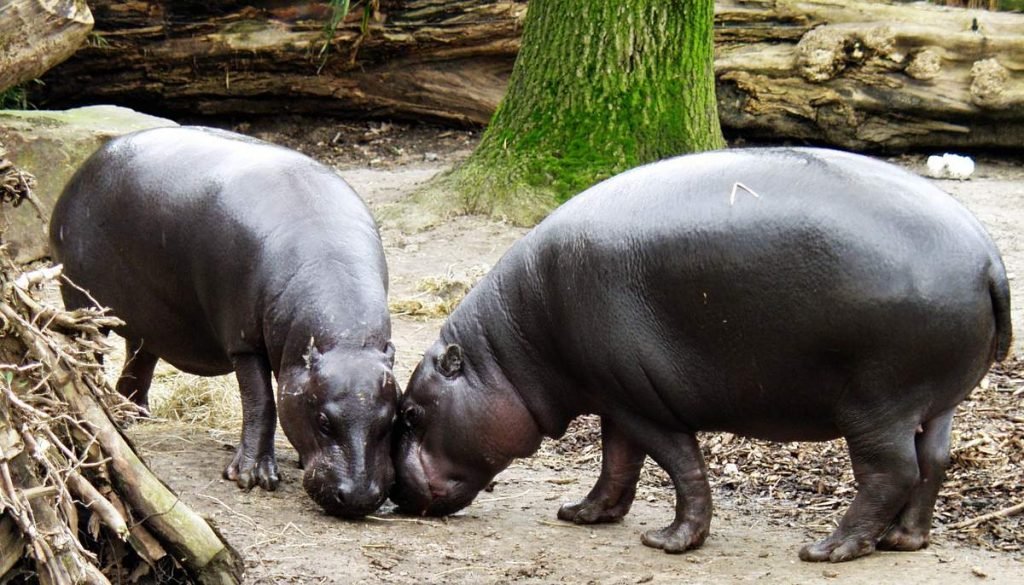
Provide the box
[224,353,279,491]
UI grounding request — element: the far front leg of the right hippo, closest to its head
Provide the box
[558,417,647,525]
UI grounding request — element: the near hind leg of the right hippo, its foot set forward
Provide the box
[800,417,921,562]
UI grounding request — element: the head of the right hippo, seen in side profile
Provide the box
[391,341,542,516]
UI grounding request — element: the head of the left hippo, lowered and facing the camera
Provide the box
[278,342,398,517]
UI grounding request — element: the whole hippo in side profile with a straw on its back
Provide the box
[391,149,1011,561]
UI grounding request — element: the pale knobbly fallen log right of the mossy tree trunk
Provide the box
[715,0,1024,151]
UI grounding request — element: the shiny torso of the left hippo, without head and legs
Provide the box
[50,127,389,373]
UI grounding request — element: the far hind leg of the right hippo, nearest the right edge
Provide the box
[878,410,953,550]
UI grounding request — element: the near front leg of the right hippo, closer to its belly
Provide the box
[616,413,712,553]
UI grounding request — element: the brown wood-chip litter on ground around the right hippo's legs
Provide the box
[535,359,1024,555]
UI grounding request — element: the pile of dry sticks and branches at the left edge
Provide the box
[0,154,243,585]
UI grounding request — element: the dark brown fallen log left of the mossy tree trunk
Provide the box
[34,0,525,124]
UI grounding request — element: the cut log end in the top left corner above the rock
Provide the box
[0,0,92,92]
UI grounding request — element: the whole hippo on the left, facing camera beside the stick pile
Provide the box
[50,127,398,517]
